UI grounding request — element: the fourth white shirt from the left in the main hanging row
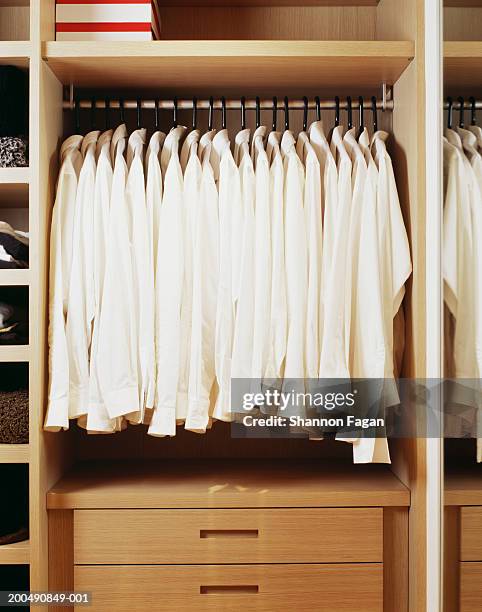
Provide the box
[97,125,140,419]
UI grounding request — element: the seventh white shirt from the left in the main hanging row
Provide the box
[149,126,186,436]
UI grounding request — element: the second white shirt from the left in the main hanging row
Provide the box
[65,131,99,418]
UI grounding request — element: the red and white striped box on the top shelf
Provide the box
[55,0,161,41]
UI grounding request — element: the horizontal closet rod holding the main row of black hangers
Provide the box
[63,97,394,112]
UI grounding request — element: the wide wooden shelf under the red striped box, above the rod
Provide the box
[43,40,415,95]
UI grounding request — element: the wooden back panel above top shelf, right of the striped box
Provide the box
[160,2,376,41]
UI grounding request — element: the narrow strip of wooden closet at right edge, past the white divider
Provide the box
[443,0,482,612]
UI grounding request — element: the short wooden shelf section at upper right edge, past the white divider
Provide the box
[444,41,482,95]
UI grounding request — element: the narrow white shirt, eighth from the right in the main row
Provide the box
[264,132,288,386]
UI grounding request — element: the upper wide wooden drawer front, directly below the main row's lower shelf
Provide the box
[74,508,383,565]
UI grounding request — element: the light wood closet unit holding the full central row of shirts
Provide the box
[0,0,427,612]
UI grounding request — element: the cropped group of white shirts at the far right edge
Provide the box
[443,126,482,462]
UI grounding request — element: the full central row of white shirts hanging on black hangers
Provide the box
[45,122,411,462]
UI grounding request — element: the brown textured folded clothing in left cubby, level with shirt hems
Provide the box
[0,389,28,444]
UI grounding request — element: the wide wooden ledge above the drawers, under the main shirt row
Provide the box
[47,460,410,509]
